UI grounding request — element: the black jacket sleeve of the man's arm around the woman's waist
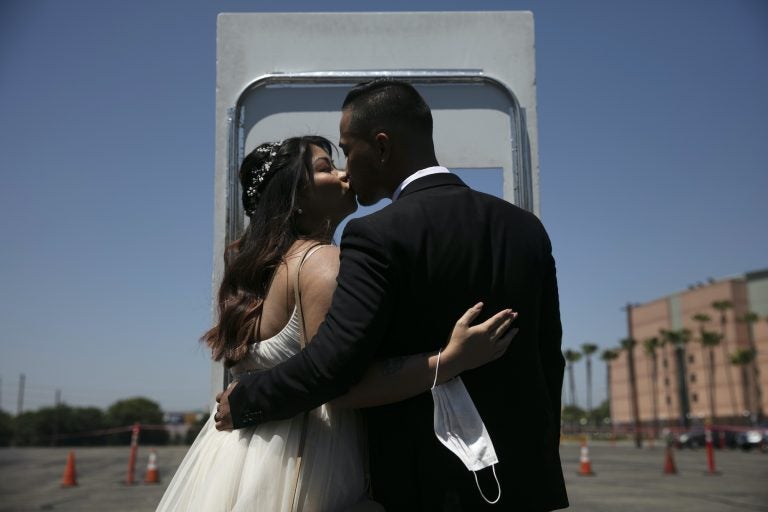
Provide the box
[222,219,394,428]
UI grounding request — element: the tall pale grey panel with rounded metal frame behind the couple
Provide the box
[211,12,539,394]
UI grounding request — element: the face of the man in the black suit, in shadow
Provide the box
[339,110,386,206]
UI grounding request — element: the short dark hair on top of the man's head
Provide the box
[341,78,432,140]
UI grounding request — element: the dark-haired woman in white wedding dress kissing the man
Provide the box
[157,136,515,512]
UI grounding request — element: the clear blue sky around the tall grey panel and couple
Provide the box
[0,0,768,412]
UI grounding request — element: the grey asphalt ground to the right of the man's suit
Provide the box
[560,443,768,512]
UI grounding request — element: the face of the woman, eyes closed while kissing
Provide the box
[300,145,357,224]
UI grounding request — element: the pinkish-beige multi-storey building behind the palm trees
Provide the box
[610,269,768,427]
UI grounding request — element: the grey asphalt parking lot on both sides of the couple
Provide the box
[0,442,768,512]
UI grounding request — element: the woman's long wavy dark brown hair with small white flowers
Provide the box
[201,136,333,366]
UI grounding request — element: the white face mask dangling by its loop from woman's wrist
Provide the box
[432,377,501,505]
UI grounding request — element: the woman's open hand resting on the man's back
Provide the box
[440,302,519,377]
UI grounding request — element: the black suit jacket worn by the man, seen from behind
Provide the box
[229,174,568,511]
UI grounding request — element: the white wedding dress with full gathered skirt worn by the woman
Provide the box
[157,309,365,512]
